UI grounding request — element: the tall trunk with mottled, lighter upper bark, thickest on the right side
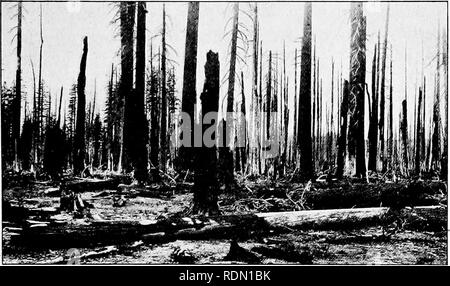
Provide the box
[349,2,366,178]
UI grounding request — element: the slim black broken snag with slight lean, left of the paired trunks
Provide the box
[73,37,88,174]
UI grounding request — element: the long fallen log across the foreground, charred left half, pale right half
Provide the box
[12,206,447,248]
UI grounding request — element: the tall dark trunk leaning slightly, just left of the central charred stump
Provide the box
[179,2,200,169]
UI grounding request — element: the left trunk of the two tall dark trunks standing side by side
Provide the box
[119,2,136,172]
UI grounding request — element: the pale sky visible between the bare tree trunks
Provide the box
[1,2,447,136]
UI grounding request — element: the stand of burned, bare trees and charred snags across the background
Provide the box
[1,2,448,214]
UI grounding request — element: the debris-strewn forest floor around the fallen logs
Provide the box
[2,171,448,264]
